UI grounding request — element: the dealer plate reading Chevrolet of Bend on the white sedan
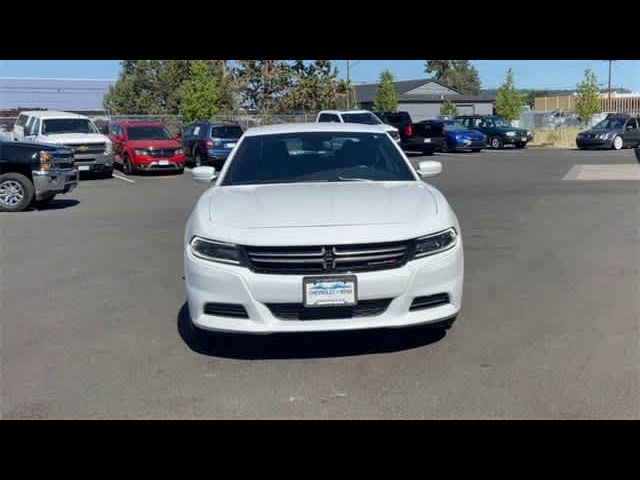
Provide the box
[302,275,358,307]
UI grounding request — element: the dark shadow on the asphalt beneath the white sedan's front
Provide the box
[177,303,445,360]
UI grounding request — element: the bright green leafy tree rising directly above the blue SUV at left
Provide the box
[180,60,218,122]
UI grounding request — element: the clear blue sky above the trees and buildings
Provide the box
[0,60,640,91]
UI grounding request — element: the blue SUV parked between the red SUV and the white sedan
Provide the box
[180,122,244,169]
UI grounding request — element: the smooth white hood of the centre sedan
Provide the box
[196,181,451,245]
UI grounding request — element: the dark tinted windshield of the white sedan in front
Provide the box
[221,132,416,186]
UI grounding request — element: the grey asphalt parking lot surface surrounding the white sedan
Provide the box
[0,149,640,419]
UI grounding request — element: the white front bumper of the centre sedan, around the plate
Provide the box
[184,240,464,334]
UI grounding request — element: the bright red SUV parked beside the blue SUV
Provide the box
[109,120,185,174]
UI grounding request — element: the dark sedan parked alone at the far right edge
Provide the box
[576,114,640,150]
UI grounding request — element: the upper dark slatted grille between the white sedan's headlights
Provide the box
[245,241,413,274]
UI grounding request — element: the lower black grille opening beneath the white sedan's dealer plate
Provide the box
[267,298,392,320]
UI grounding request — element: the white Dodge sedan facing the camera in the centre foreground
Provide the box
[184,123,463,334]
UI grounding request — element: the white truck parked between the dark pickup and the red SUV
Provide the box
[13,110,113,177]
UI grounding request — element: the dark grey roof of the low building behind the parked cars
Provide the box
[354,78,494,103]
